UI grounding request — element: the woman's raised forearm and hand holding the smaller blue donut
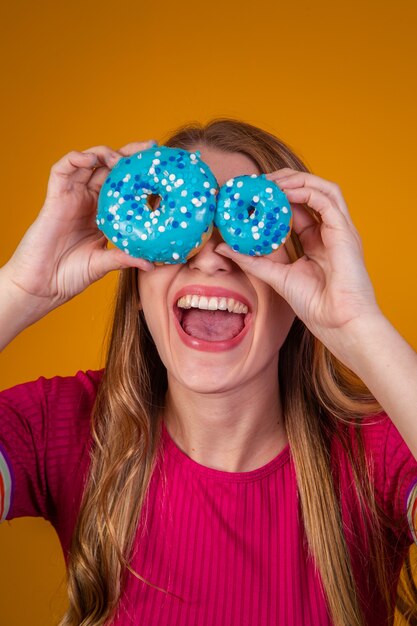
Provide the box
[216,168,417,459]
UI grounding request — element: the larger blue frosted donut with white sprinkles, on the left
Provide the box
[96,146,218,264]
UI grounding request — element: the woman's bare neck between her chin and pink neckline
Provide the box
[164,368,288,472]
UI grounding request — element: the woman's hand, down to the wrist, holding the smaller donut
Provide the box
[216,168,382,361]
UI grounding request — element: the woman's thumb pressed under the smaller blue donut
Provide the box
[215,243,289,296]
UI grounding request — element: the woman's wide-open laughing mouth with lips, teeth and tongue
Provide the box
[174,293,251,350]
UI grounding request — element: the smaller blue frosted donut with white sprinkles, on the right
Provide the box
[214,174,292,256]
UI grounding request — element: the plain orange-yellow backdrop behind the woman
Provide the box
[0,0,417,626]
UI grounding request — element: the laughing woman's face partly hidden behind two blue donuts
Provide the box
[139,145,294,393]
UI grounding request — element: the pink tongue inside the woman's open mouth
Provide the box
[181,309,244,341]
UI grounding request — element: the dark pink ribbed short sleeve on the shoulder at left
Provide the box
[0,371,101,523]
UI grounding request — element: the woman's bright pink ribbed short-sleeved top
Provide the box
[0,372,417,626]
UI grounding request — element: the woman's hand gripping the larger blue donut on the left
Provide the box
[2,141,153,321]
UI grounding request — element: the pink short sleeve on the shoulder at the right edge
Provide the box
[364,414,417,544]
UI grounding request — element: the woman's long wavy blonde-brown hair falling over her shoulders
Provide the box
[59,118,390,626]
